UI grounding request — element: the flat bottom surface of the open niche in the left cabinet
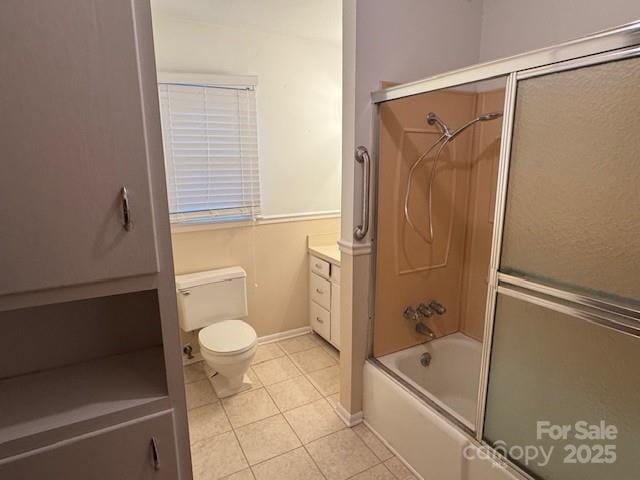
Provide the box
[0,347,168,458]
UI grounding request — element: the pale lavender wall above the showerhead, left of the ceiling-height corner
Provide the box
[352,0,482,150]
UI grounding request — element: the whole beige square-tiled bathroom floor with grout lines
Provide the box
[184,334,415,480]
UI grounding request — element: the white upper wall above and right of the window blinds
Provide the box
[153,7,342,217]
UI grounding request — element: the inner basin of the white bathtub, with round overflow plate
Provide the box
[378,333,482,430]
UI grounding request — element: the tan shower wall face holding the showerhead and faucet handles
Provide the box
[374,91,476,355]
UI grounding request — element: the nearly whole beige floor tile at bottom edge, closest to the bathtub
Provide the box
[306,428,379,480]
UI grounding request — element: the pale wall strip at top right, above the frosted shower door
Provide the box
[479,0,640,61]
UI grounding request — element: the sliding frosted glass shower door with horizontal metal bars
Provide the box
[483,51,640,480]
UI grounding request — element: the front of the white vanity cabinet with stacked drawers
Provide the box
[309,254,340,349]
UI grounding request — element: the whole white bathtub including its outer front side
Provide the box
[363,334,523,480]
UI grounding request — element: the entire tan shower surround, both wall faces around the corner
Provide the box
[373,89,504,356]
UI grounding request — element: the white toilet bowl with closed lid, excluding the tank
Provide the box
[198,320,258,398]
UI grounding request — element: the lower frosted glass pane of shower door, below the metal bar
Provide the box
[484,295,640,480]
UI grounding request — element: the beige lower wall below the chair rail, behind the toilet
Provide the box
[171,217,340,347]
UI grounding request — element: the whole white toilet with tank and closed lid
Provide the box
[176,267,258,398]
